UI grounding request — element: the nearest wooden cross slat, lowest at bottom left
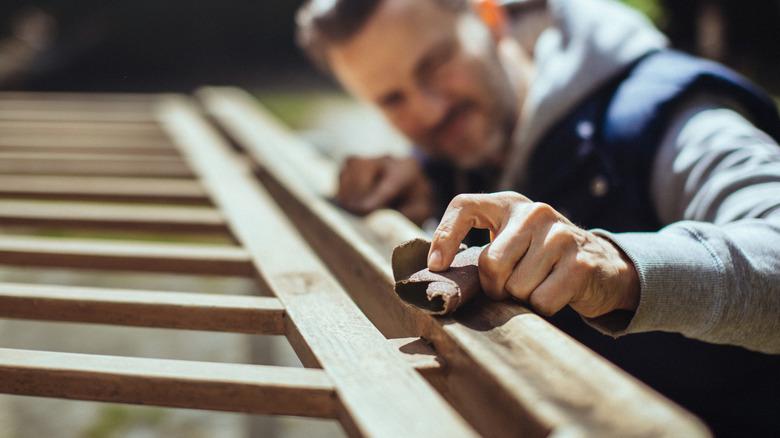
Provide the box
[0,348,339,418]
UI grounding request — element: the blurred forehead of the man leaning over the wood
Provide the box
[328,0,457,99]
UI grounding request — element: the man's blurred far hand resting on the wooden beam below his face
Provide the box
[336,156,434,225]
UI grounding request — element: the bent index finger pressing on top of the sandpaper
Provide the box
[428,194,507,271]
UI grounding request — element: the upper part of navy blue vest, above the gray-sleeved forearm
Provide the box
[520,50,780,232]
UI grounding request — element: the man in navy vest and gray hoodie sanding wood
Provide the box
[298,0,780,434]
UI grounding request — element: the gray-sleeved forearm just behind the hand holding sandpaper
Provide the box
[589,218,780,354]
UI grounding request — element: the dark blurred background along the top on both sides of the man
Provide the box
[0,0,780,94]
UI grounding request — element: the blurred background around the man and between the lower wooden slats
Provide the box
[0,0,780,438]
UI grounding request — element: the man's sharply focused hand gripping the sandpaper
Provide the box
[428,192,639,318]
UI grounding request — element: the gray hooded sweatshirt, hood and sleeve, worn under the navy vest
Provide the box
[502,0,780,354]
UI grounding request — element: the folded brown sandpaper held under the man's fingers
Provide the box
[392,239,482,315]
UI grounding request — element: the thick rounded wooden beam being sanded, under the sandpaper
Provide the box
[200,89,708,436]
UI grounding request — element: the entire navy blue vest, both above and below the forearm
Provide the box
[427,50,780,436]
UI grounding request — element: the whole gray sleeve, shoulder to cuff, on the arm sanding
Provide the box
[587,97,780,354]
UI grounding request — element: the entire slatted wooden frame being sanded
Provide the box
[0,88,708,436]
